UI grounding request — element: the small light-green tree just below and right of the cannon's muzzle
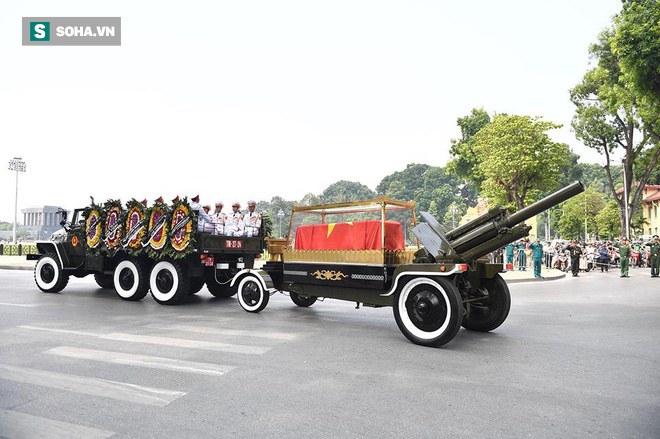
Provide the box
[557,188,605,238]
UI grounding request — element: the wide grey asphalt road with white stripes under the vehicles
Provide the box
[0,269,660,439]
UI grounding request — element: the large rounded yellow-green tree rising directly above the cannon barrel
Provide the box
[472,114,570,209]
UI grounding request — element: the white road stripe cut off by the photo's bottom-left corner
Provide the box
[0,409,114,439]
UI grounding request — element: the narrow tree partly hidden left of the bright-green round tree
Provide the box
[447,108,490,191]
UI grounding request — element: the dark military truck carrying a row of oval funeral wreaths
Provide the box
[27,197,265,305]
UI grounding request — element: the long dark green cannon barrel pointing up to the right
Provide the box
[447,181,584,256]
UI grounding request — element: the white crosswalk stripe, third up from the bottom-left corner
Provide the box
[45,346,235,376]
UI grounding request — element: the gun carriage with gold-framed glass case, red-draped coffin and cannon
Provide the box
[238,181,584,346]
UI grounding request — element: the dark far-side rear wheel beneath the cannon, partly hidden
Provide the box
[463,274,511,332]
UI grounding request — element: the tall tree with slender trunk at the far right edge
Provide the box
[571,6,660,235]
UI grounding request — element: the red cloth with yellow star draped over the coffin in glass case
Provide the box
[295,221,404,250]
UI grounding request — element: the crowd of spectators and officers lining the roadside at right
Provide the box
[501,235,660,278]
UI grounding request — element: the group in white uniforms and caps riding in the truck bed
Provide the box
[190,195,261,237]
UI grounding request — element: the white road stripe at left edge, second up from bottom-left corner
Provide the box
[0,364,186,407]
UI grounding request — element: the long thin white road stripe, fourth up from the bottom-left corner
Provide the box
[17,325,271,355]
